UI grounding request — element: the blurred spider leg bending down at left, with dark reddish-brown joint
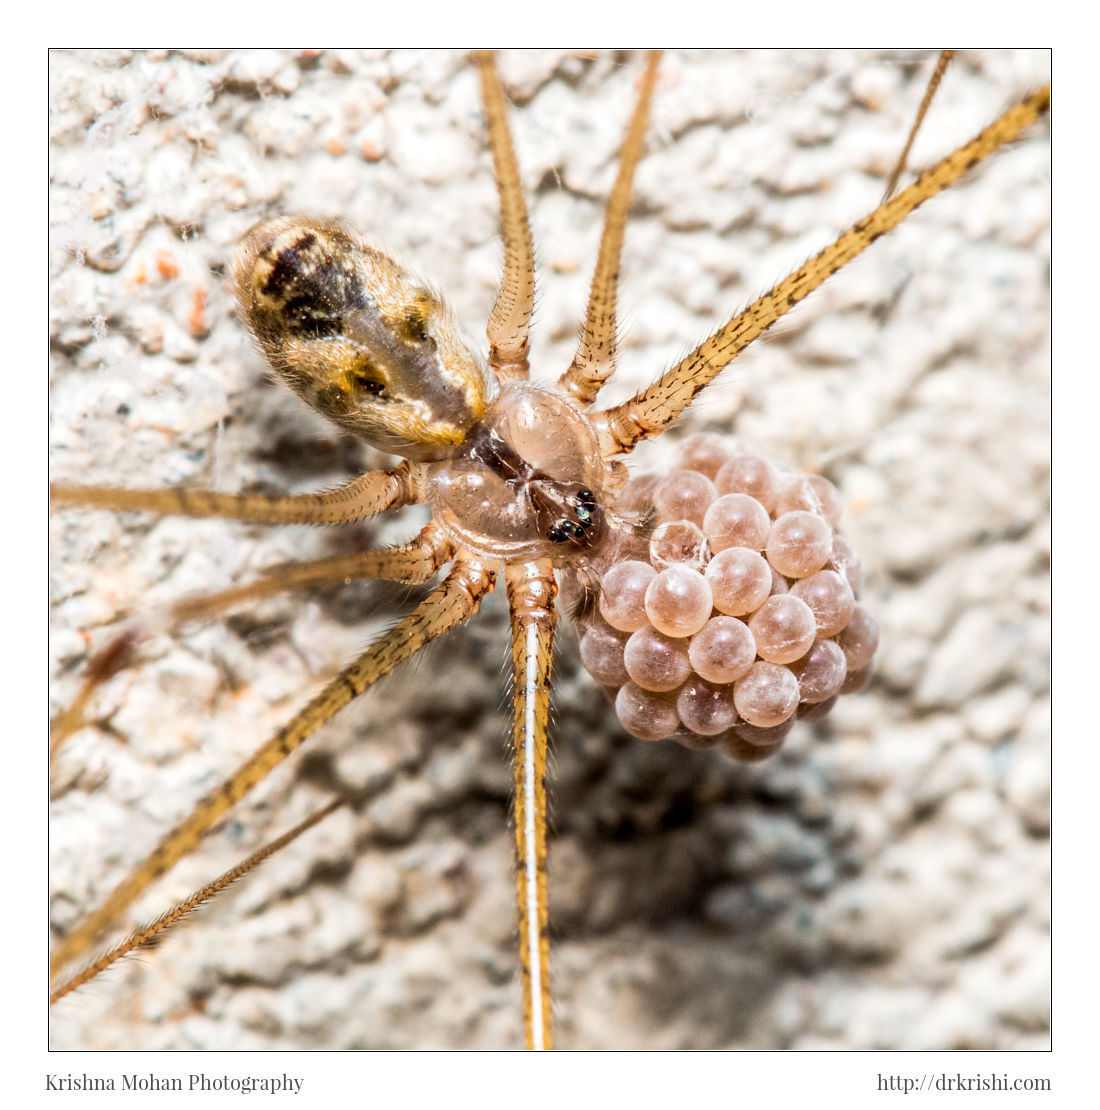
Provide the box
[50,522,454,759]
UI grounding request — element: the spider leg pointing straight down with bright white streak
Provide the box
[505,559,557,1049]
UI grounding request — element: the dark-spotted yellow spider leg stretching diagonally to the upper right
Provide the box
[593,84,1050,458]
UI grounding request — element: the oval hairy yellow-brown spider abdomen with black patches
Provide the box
[233,216,488,461]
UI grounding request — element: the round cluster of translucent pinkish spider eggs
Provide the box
[581,435,878,760]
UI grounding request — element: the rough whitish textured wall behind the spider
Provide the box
[55,49,1046,1047]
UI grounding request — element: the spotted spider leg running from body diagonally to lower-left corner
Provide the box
[50,559,496,970]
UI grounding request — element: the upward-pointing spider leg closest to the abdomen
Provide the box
[474,51,535,382]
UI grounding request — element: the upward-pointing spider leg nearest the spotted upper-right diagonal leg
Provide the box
[557,50,660,408]
